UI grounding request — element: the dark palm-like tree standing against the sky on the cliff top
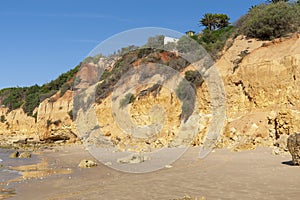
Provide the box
[199,13,230,31]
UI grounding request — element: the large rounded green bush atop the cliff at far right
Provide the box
[237,1,300,40]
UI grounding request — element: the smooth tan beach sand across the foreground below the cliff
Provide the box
[5,146,300,200]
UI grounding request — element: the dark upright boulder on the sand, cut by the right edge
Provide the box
[287,133,300,165]
